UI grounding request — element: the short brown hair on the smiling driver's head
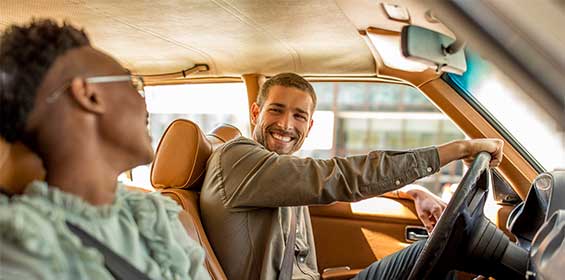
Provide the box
[256,73,318,110]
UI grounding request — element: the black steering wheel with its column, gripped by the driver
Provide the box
[408,152,528,280]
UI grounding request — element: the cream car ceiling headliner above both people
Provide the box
[0,0,448,76]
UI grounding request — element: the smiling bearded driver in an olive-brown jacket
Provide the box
[200,73,502,280]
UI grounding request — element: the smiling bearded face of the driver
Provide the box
[251,85,314,155]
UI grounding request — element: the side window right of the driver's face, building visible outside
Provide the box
[299,82,465,201]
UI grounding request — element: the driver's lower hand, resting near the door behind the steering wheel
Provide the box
[399,185,447,232]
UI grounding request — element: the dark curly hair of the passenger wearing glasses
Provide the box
[0,19,90,142]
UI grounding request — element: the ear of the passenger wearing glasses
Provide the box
[69,77,105,114]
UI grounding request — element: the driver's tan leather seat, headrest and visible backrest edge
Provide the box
[151,119,241,280]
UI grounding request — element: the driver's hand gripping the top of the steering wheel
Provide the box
[438,138,504,168]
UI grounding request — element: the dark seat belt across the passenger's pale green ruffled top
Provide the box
[66,221,151,280]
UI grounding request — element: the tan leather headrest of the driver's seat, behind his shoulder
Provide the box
[151,119,241,189]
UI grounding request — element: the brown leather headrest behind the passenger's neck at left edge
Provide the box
[0,139,45,194]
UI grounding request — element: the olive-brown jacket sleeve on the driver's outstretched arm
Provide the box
[214,139,439,208]
